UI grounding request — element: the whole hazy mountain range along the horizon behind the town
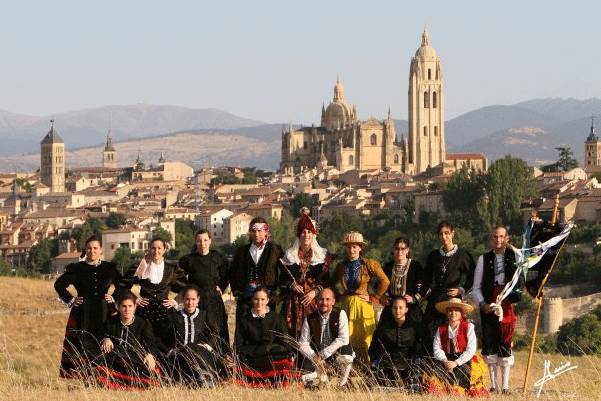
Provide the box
[0,98,601,171]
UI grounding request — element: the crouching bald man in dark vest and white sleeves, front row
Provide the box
[298,288,355,387]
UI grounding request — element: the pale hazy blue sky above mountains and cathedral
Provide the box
[0,0,601,124]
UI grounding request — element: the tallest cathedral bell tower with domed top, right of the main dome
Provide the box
[407,29,446,174]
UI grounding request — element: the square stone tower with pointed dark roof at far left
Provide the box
[40,120,65,192]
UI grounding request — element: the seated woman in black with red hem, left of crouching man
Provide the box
[234,287,300,387]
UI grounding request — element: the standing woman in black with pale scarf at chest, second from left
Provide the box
[121,238,185,351]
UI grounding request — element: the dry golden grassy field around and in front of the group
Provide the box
[0,277,601,401]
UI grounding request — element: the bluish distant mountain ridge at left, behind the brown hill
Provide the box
[0,104,264,155]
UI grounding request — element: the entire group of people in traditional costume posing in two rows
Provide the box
[55,209,520,395]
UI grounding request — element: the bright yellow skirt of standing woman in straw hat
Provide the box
[342,295,376,363]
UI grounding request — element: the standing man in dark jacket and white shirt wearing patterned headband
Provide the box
[229,217,284,317]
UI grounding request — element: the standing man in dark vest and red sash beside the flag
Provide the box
[472,226,523,394]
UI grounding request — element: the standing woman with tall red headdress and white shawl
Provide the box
[280,208,333,339]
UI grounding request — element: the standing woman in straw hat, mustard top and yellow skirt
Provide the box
[335,231,390,363]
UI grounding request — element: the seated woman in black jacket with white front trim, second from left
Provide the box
[167,286,224,387]
